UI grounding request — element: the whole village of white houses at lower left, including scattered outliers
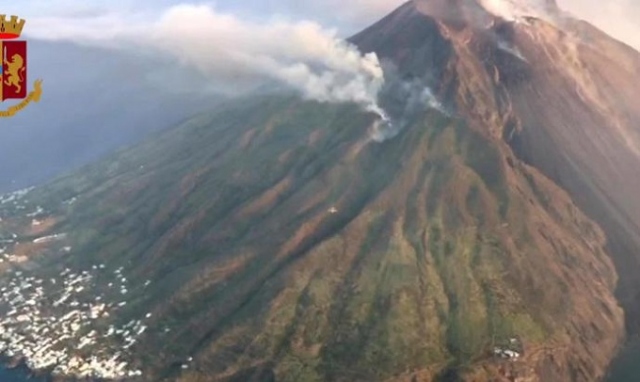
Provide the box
[0,188,204,380]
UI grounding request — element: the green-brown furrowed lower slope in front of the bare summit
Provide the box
[25,98,619,381]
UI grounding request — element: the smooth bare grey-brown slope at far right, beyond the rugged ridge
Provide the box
[502,19,640,333]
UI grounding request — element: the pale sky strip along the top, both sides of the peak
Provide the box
[0,0,640,50]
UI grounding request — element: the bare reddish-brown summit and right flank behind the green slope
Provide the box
[353,0,640,334]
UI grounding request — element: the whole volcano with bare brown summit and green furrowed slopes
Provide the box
[2,0,640,382]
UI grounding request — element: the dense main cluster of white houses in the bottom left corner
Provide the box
[0,264,151,379]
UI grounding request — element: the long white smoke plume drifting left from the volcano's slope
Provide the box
[31,5,384,116]
